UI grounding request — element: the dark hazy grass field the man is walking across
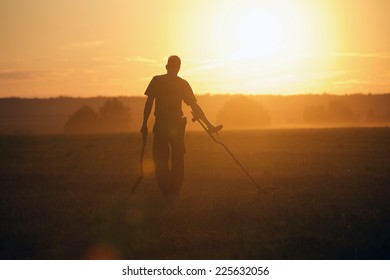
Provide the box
[0,128,390,259]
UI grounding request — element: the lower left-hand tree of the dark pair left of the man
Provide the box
[64,105,99,133]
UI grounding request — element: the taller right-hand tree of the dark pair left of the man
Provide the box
[99,98,131,132]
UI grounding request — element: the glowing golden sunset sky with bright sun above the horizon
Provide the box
[0,0,390,98]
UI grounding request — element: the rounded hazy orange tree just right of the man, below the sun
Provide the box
[217,96,270,128]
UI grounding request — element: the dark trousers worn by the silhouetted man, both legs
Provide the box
[153,118,187,197]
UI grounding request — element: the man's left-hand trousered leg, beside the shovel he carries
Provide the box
[153,122,170,195]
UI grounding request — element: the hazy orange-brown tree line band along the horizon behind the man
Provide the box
[0,94,390,134]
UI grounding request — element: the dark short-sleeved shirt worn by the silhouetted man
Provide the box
[145,74,196,118]
